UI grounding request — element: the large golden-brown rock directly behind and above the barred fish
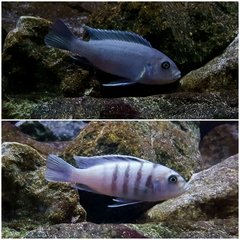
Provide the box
[63,121,200,178]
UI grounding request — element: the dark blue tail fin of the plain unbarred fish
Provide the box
[44,19,76,51]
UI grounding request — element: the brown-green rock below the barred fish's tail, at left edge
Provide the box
[2,142,85,237]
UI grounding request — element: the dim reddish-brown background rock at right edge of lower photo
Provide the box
[199,121,238,169]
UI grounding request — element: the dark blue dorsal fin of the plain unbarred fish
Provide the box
[84,25,152,47]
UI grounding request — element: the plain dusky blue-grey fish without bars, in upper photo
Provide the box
[44,19,181,87]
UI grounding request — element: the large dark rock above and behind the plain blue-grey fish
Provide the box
[89,2,238,73]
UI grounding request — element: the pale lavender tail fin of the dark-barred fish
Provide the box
[45,155,75,182]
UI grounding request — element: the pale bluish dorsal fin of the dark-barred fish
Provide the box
[73,155,149,168]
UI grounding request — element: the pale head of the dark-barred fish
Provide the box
[153,168,188,201]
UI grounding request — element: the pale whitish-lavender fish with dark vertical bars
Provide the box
[45,154,188,207]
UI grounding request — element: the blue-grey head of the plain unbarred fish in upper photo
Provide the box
[139,55,181,85]
